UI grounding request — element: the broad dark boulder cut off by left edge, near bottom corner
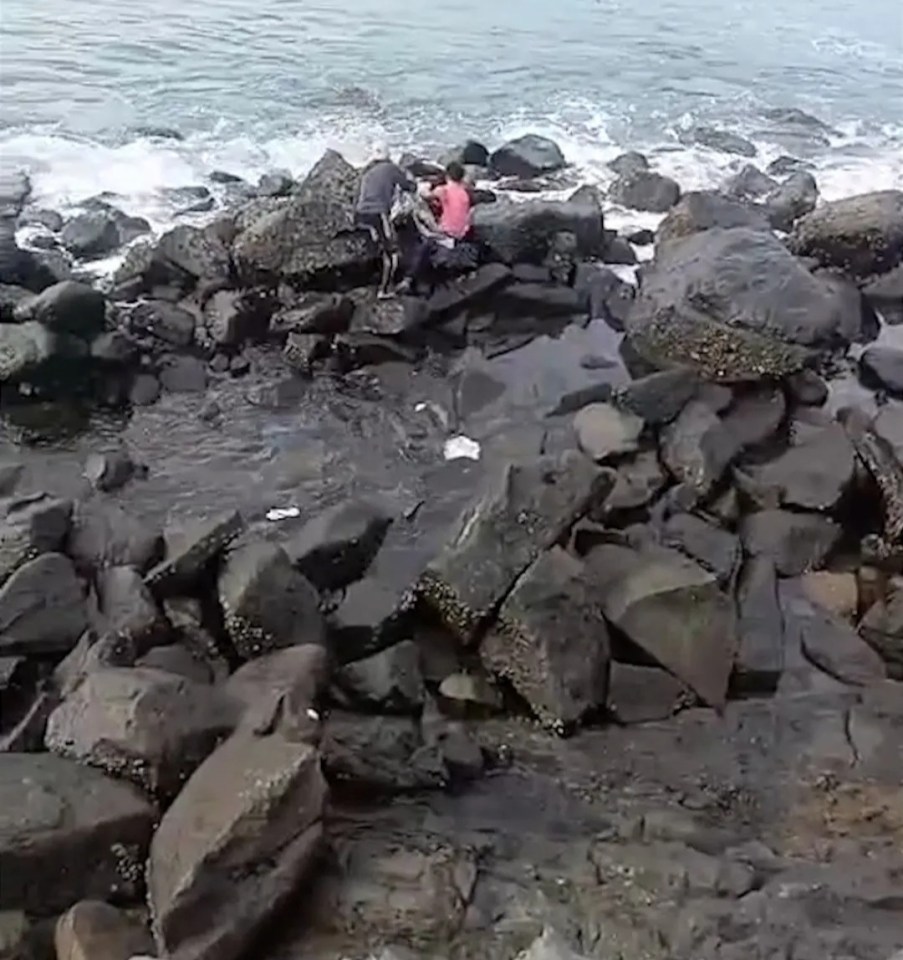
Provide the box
[0,753,155,916]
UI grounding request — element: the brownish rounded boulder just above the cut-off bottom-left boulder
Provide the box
[46,667,236,801]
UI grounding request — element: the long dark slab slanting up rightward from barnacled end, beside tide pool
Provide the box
[417,452,613,641]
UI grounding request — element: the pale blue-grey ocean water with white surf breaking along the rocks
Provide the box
[0,0,903,240]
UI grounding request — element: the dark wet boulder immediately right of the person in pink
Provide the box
[473,193,605,263]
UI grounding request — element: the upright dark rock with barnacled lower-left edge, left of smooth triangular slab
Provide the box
[480,547,609,732]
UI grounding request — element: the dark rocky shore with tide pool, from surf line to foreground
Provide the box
[0,137,903,960]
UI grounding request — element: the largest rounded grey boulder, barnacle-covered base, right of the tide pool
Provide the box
[628,227,864,380]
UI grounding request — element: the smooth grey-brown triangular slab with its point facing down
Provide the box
[586,544,735,707]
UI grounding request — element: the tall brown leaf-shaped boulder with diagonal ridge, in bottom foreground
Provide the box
[147,731,326,960]
